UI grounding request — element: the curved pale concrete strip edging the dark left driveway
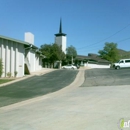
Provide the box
[0,70,85,111]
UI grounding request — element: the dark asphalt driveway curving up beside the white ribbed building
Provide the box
[0,70,78,107]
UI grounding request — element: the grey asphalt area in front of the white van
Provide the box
[82,69,130,87]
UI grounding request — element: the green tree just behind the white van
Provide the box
[98,42,119,63]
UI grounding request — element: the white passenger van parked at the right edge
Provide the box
[113,59,130,69]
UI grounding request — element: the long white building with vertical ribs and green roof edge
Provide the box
[0,33,43,77]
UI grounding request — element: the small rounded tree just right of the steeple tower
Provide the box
[66,45,77,64]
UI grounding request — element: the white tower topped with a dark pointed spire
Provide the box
[55,19,67,54]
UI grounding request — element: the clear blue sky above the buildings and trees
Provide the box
[0,0,130,55]
